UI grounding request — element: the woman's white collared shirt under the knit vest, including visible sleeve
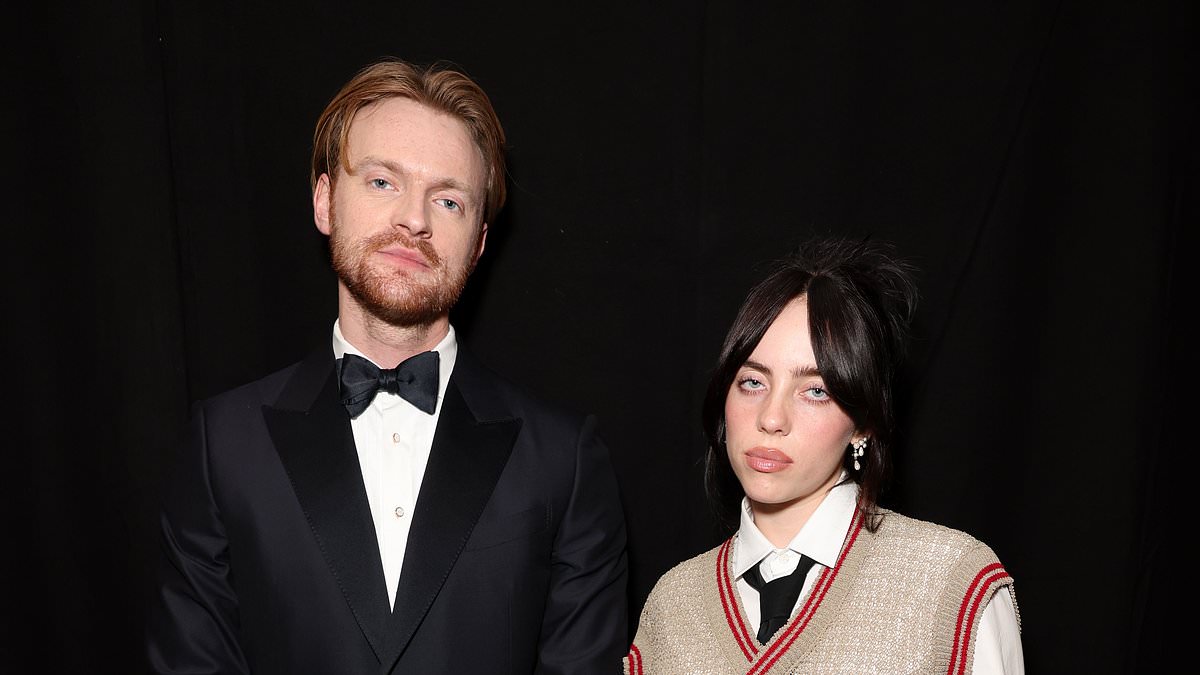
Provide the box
[733,474,1025,675]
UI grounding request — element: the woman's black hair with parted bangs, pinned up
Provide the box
[702,238,917,531]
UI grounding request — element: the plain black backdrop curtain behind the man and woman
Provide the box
[0,0,1200,673]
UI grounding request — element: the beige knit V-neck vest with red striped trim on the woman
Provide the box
[624,512,1020,675]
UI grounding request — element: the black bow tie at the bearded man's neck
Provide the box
[337,352,438,419]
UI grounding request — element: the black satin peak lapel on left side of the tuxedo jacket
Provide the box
[263,353,390,659]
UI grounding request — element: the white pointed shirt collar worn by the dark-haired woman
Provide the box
[733,473,858,579]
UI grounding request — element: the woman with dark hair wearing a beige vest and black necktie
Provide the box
[623,239,1025,675]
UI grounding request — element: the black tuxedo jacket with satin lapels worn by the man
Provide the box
[148,346,629,675]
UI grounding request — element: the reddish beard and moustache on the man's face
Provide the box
[329,213,475,327]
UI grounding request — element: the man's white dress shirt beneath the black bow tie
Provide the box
[334,321,458,608]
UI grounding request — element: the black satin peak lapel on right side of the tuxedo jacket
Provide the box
[384,374,521,671]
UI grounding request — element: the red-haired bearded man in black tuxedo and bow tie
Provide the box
[148,60,628,675]
